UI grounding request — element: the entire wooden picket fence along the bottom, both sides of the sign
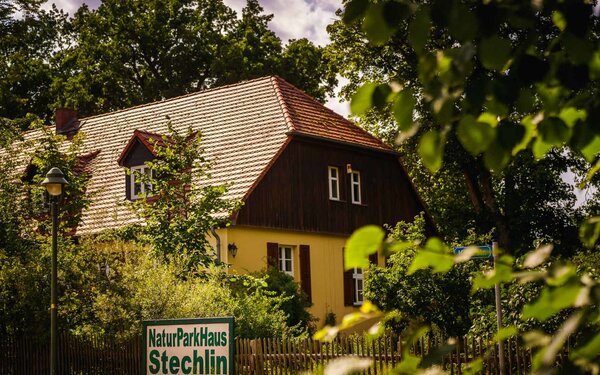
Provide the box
[0,335,567,375]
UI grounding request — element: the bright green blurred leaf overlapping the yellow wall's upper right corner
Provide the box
[344,225,385,270]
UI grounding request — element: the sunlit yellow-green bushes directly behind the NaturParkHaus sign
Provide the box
[74,241,292,338]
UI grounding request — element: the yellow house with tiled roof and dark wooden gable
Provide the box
[12,77,433,322]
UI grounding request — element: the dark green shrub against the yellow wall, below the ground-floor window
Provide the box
[252,267,315,332]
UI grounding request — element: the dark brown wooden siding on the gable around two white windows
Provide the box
[235,137,433,234]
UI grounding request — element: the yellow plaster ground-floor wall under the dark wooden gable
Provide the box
[211,226,376,327]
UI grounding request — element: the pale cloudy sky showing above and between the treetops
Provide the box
[44,0,349,117]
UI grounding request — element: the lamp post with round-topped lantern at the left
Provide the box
[42,167,68,375]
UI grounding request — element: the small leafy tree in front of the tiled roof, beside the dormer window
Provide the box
[129,123,239,271]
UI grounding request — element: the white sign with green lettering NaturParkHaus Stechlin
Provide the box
[142,317,234,375]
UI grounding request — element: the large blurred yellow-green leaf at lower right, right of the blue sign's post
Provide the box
[522,284,582,322]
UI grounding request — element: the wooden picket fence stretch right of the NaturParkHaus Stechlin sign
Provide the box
[236,336,540,375]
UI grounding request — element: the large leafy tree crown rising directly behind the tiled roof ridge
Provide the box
[51,0,337,115]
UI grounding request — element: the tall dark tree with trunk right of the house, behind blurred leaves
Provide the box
[328,2,596,255]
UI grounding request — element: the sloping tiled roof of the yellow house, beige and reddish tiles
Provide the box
[12,77,392,233]
